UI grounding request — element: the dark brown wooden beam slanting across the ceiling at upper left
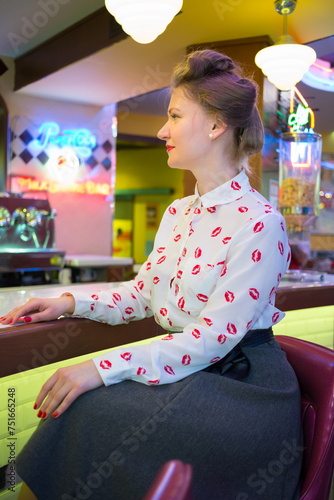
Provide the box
[14,7,128,90]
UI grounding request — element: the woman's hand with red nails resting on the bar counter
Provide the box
[0,293,75,325]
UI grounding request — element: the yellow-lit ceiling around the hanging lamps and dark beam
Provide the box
[0,0,334,133]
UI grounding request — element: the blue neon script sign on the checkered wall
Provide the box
[31,122,96,158]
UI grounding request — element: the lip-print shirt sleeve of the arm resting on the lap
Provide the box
[93,213,290,385]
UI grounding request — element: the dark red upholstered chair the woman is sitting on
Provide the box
[276,335,334,500]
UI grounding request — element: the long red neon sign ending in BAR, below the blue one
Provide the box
[16,177,111,196]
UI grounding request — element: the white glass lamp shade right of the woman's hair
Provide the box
[255,43,317,90]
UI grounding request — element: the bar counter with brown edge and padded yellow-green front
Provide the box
[0,281,334,500]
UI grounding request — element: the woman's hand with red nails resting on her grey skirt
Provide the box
[34,360,103,418]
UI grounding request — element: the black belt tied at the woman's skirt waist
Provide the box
[203,327,274,380]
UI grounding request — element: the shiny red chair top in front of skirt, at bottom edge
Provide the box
[142,460,192,500]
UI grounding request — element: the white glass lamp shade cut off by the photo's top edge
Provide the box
[105,0,183,43]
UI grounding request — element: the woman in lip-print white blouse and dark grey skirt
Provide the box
[2,50,302,500]
